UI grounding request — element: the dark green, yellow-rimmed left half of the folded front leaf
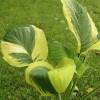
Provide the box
[25,61,57,95]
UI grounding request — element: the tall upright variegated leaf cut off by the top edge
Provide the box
[61,0,98,53]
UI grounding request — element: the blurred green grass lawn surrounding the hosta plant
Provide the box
[0,0,100,100]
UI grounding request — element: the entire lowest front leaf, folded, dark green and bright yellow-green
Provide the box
[25,58,76,95]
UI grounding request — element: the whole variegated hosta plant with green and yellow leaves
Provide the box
[1,0,100,100]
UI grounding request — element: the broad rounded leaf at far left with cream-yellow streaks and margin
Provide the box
[1,25,48,67]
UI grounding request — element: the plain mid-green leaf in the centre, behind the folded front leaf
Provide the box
[48,41,67,66]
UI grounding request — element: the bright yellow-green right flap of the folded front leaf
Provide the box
[48,58,76,93]
